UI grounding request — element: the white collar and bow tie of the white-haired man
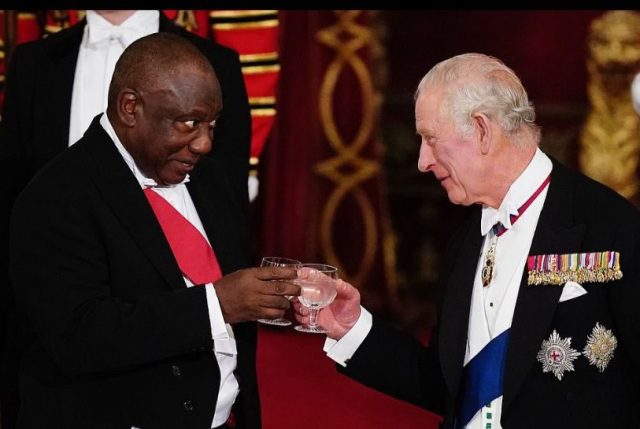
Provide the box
[480,148,553,235]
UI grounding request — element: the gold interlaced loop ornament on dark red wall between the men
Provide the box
[314,10,397,288]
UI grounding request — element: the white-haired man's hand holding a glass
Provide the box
[293,276,361,340]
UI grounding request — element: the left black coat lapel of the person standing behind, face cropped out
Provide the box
[34,22,85,155]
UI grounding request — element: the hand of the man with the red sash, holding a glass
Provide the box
[215,267,300,323]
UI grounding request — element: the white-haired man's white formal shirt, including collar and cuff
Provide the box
[324,149,552,429]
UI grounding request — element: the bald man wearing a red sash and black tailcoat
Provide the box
[10,33,299,429]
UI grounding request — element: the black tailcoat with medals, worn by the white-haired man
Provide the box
[338,162,640,429]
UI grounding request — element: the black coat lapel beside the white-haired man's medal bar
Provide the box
[503,161,585,411]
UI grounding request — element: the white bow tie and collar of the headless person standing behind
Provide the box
[83,10,160,48]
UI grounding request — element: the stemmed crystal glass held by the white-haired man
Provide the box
[294,263,338,334]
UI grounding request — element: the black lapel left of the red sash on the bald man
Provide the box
[77,118,185,289]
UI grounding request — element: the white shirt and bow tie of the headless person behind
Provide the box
[69,10,160,146]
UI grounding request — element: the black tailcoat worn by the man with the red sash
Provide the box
[10,118,260,429]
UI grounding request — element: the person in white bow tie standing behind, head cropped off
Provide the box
[0,10,251,429]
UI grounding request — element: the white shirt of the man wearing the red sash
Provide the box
[100,114,240,428]
